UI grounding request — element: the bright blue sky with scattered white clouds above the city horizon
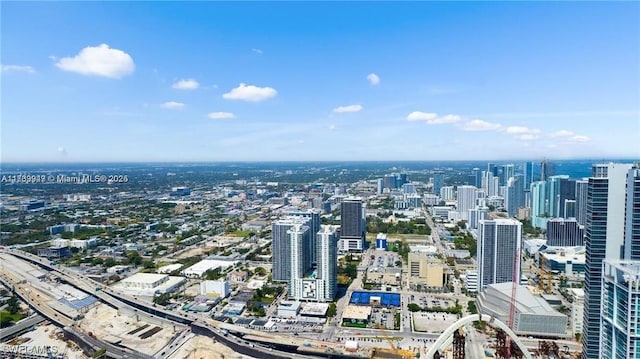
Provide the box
[0,2,640,162]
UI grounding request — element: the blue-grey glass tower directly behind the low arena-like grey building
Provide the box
[477,218,522,291]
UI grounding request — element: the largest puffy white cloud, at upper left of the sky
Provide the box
[56,44,135,79]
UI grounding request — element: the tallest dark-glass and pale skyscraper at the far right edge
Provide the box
[582,163,631,359]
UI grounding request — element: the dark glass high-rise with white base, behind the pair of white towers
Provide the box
[340,197,367,252]
